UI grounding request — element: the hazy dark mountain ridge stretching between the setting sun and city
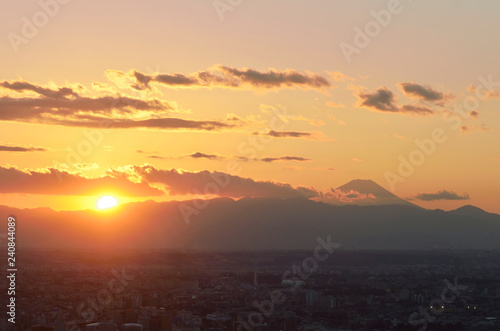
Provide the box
[0,198,500,250]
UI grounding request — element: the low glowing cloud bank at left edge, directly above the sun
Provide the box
[0,167,164,196]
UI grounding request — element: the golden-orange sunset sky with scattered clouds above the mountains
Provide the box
[0,0,500,213]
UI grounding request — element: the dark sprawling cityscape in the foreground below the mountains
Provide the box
[0,250,500,331]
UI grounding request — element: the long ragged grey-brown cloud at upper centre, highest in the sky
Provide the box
[106,65,333,90]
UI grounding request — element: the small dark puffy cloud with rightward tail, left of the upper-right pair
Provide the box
[358,87,435,116]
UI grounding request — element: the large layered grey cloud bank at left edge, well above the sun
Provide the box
[0,81,236,131]
